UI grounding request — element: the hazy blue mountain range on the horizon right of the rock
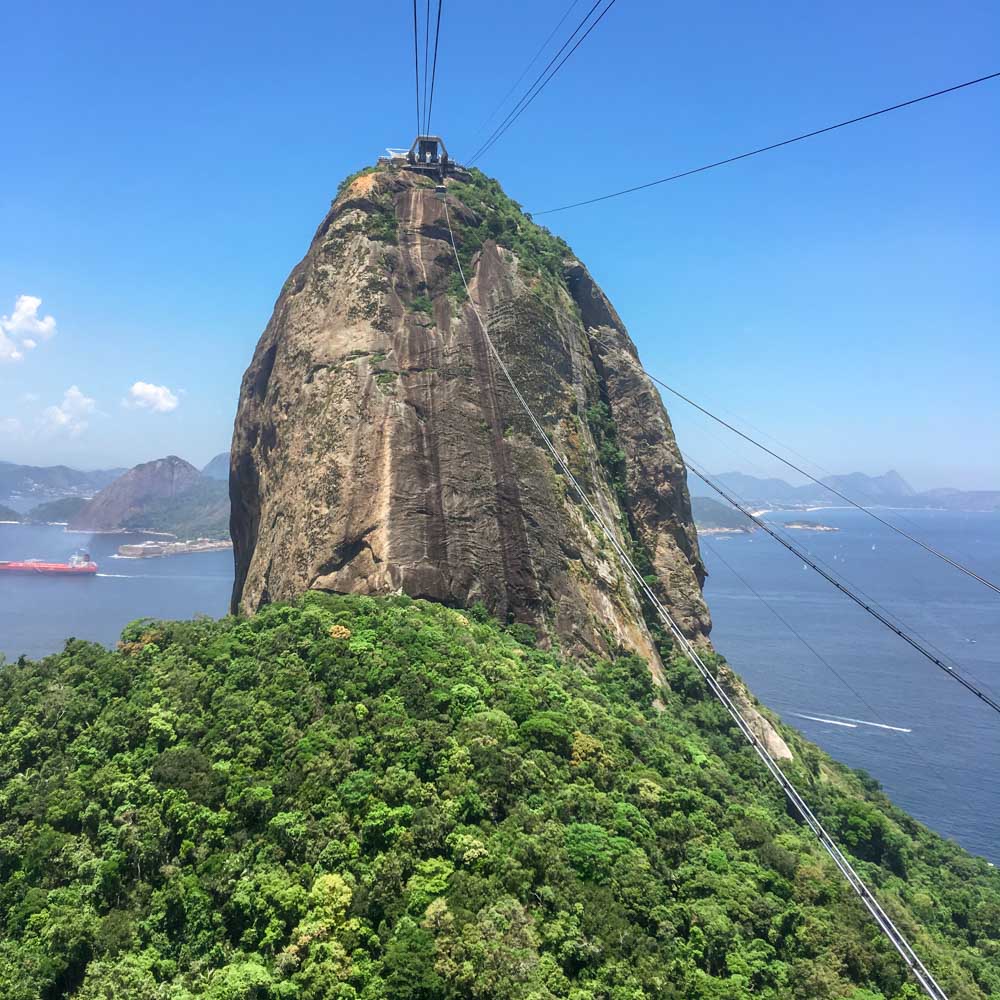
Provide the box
[688,470,1000,511]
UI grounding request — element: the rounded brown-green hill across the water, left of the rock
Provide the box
[70,455,229,538]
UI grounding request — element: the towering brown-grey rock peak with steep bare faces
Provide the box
[230,169,709,665]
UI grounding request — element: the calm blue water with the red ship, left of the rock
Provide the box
[0,524,233,660]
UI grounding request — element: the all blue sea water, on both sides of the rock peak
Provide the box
[0,510,1000,863]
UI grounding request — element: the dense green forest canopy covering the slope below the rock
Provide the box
[0,594,1000,1000]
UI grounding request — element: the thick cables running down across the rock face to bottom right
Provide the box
[444,196,948,1000]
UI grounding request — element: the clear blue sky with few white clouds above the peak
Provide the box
[0,0,1000,488]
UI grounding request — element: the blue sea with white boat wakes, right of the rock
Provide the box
[702,509,1000,863]
